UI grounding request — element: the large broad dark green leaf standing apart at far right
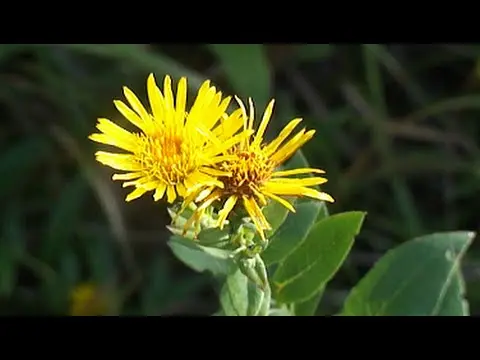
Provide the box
[343,231,474,316]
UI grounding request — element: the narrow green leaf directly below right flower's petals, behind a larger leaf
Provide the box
[262,201,324,265]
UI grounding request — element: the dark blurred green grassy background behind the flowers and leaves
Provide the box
[0,44,480,315]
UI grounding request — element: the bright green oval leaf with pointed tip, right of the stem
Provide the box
[273,211,365,303]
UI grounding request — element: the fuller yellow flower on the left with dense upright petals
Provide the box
[89,74,248,203]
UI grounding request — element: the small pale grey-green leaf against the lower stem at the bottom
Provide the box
[220,269,265,316]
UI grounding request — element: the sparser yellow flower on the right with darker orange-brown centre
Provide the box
[188,98,334,240]
